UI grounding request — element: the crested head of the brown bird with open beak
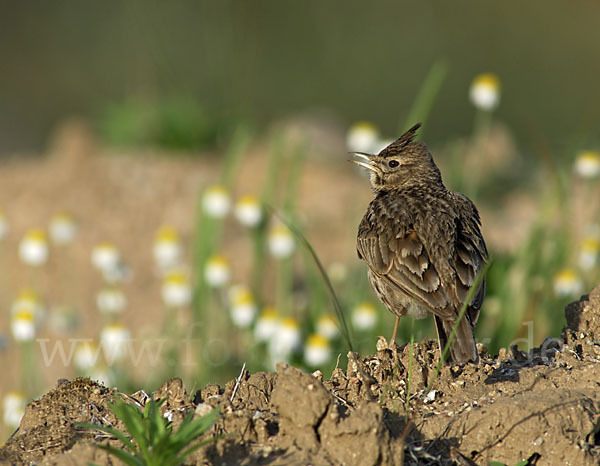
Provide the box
[352,123,442,192]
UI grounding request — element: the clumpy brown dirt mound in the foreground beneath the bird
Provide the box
[0,287,600,465]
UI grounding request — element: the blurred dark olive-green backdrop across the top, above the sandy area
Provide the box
[0,0,600,153]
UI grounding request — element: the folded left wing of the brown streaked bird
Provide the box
[357,200,456,319]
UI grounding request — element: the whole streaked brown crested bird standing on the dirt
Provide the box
[355,124,487,363]
